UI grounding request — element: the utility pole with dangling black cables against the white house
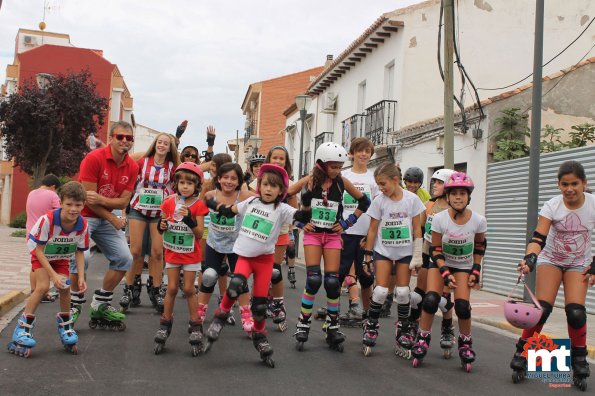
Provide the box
[444,0,455,169]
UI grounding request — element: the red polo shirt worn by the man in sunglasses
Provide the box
[79,145,138,217]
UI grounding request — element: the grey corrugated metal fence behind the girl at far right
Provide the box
[483,146,595,313]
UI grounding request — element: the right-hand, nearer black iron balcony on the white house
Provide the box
[365,100,397,146]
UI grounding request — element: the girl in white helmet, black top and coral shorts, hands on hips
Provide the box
[290,143,370,351]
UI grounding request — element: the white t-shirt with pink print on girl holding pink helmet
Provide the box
[537,194,595,267]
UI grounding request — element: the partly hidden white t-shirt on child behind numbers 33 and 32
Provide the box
[341,169,380,235]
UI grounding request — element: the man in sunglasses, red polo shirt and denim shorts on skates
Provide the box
[70,121,138,330]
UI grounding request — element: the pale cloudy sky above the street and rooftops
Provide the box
[0,0,421,152]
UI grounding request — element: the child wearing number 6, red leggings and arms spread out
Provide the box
[207,164,310,367]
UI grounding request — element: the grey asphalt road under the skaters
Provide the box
[0,255,584,396]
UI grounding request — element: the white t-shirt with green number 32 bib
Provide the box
[366,190,426,260]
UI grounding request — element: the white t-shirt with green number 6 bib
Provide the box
[233,198,297,257]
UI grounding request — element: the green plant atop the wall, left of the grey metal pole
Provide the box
[494,108,530,161]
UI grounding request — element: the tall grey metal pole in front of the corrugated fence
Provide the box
[524,0,544,302]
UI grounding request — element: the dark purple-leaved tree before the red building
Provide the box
[0,70,108,187]
